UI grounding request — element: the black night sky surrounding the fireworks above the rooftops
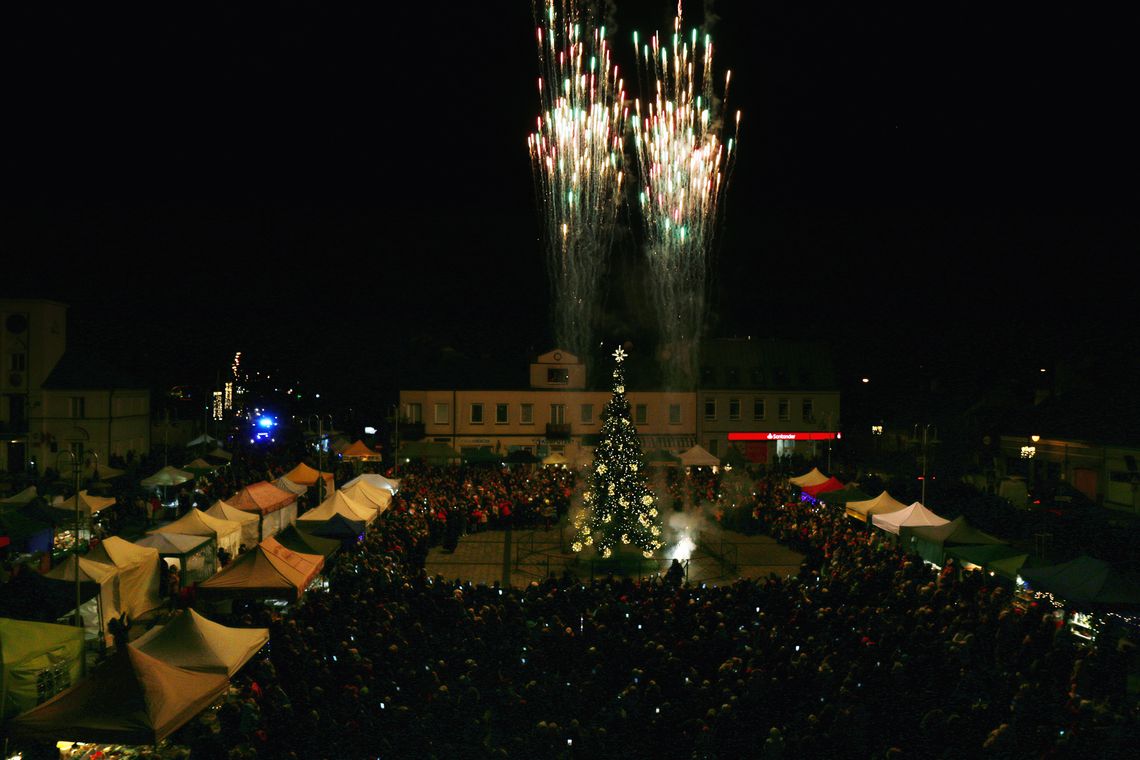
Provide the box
[0,1,1140,426]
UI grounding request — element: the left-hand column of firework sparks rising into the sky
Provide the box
[528,0,628,353]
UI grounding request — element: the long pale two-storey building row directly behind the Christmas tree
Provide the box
[400,342,839,463]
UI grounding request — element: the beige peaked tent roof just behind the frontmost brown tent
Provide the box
[131,610,269,678]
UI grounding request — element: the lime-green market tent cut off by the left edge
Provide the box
[0,618,86,719]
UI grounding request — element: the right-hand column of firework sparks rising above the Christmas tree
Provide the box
[630,2,740,386]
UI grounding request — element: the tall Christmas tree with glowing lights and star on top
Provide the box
[571,349,665,557]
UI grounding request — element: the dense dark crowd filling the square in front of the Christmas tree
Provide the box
[158,471,1140,758]
